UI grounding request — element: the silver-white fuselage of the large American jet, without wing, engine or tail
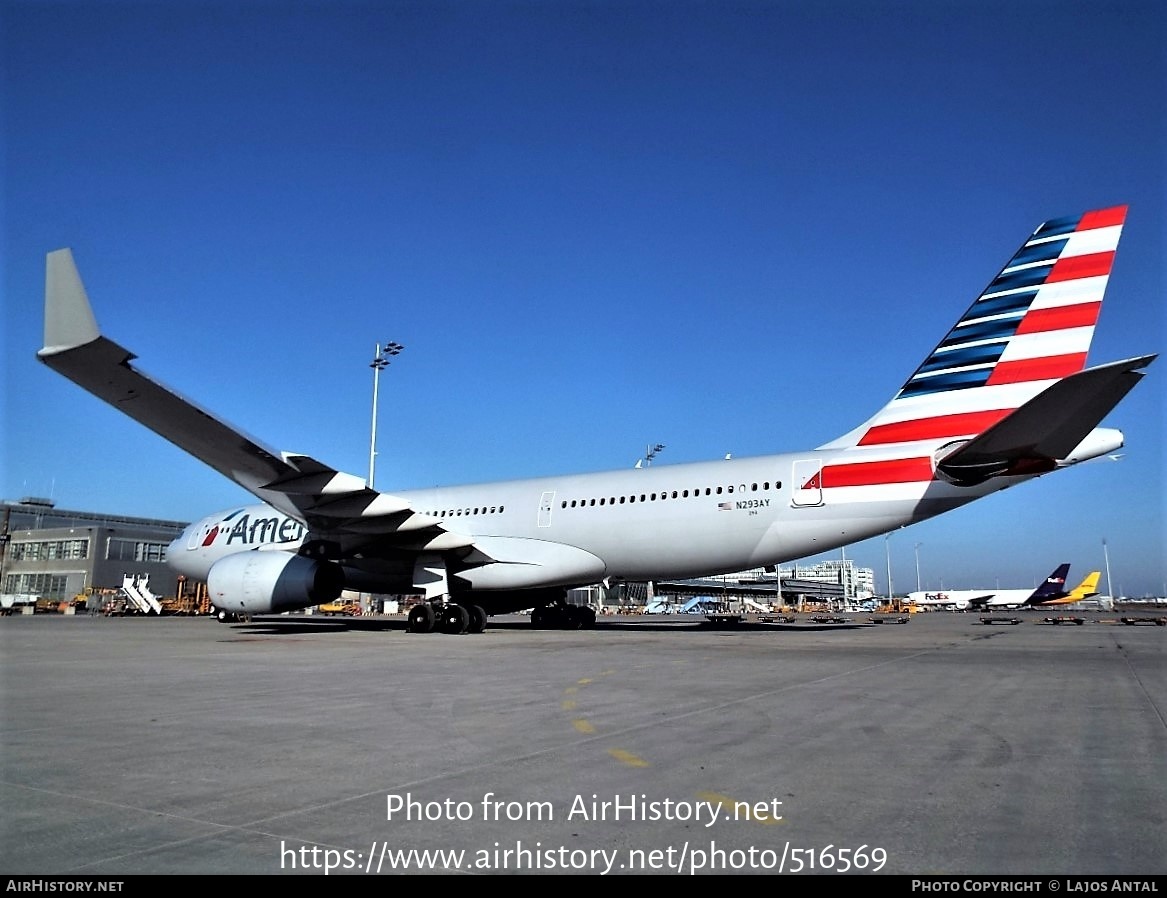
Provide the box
[168,450,1026,590]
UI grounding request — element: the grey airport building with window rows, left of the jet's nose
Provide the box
[0,497,186,600]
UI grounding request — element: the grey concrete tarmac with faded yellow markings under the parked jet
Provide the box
[0,613,1167,877]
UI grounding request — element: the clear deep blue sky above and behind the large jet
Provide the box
[0,0,1167,594]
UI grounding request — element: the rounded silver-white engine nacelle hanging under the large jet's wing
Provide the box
[207,552,344,614]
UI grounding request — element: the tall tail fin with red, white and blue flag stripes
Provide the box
[819,206,1127,450]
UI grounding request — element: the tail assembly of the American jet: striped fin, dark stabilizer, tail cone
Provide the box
[820,206,1154,486]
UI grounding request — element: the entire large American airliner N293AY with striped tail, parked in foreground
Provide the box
[37,207,1155,633]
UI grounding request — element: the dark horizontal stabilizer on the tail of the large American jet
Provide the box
[936,355,1155,486]
